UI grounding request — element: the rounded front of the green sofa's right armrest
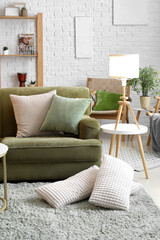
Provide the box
[79,115,100,139]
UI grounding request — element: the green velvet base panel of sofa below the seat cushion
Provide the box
[0,161,100,182]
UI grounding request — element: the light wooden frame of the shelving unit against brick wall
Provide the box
[0,13,43,88]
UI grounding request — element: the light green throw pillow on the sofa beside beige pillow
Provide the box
[40,95,91,134]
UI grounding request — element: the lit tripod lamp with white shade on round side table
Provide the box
[109,54,139,130]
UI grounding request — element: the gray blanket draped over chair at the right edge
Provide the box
[150,113,160,157]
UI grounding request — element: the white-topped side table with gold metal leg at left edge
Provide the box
[0,143,8,213]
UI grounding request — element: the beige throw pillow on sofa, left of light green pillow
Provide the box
[10,90,56,138]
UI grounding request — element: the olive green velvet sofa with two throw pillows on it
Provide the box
[0,87,102,181]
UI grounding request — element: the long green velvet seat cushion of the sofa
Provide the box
[2,137,102,163]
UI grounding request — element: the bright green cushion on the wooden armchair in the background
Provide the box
[94,90,122,111]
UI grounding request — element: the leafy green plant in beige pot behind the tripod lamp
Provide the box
[127,66,160,109]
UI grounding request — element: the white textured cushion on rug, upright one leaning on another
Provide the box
[89,155,134,210]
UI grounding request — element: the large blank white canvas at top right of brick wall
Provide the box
[113,0,148,25]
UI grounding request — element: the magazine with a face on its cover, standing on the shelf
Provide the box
[18,34,35,55]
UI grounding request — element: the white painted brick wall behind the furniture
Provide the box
[0,0,160,124]
